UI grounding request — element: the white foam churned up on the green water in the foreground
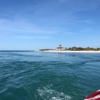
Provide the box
[37,86,71,100]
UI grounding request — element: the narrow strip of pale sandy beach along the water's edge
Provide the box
[39,50,100,53]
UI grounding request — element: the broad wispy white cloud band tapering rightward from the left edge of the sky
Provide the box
[0,19,58,34]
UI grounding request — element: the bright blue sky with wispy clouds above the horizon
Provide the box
[0,0,100,50]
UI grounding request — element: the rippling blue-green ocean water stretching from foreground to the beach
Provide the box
[0,51,100,100]
